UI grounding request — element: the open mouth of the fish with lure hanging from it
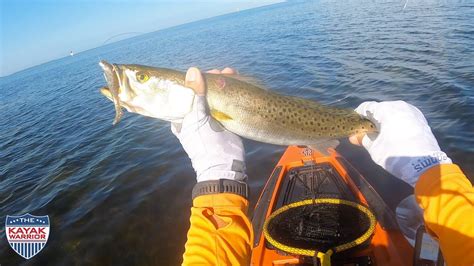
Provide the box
[99,60,123,125]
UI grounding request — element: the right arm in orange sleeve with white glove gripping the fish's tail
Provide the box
[350,101,474,265]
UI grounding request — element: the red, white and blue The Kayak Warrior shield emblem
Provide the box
[5,213,49,259]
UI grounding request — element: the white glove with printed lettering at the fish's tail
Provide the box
[355,101,452,186]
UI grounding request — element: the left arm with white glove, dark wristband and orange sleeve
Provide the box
[171,68,253,265]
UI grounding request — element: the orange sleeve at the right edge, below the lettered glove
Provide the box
[415,164,474,265]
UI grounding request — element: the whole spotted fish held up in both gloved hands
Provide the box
[100,61,377,148]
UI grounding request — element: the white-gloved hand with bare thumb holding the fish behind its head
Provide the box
[171,68,247,182]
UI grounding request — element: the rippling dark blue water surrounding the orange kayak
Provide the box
[0,0,474,265]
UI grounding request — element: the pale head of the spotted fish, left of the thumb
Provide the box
[99,61,195,123]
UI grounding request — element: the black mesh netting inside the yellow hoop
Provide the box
[267,203,370,251]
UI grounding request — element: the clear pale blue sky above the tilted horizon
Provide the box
[0,0,281,77]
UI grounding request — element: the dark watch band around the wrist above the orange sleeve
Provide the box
[192,179,248,199]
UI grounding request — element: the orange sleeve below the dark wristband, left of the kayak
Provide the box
[183,193,253,265]
